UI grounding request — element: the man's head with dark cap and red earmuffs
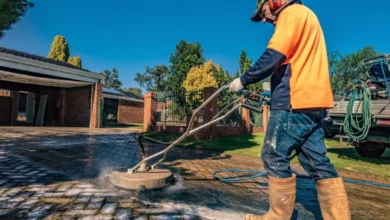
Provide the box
[251,0,301,24]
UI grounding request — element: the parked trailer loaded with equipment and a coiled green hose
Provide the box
[325,54,390,158]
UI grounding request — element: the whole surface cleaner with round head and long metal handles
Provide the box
[111,85,269,190]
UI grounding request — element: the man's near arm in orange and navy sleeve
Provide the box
[240,12,302,86]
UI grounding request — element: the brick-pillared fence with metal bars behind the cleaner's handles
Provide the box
[144,88,268,139]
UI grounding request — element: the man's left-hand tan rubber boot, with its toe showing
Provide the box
[245,175,296,220]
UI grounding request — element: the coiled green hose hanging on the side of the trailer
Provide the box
[344,85,371,141]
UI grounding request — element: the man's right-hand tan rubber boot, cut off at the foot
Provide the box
[316,177,351,220]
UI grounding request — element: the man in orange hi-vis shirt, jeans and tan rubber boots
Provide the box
[230,0,350,220]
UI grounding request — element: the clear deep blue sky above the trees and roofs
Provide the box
[0,0,390,90]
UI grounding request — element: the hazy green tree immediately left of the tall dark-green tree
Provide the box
[134,65,169,92]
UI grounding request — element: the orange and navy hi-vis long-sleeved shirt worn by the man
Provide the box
[241,4,334,110]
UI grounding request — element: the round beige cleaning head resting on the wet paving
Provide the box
[111,169,174,190]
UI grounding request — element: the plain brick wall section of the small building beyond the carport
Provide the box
[118,100,144,124]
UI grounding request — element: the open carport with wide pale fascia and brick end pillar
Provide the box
[0,47,104,128]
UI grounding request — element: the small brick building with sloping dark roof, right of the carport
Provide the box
[103,88,144,124]
